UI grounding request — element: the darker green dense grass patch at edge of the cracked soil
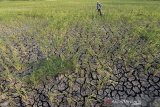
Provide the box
[24,56,74,84]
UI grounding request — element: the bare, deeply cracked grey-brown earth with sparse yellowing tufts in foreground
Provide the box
[1,60,160,107]
